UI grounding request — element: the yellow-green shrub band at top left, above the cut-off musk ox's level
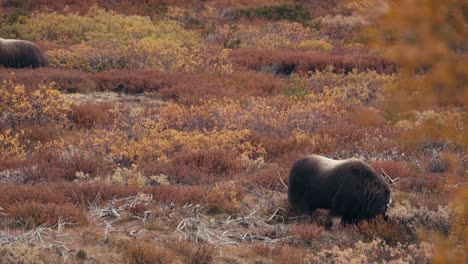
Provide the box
[17,6,202,47]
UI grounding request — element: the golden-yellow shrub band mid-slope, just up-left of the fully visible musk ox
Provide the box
[73,120,265,162]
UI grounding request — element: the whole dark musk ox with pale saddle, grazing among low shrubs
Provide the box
[288,155,390,229]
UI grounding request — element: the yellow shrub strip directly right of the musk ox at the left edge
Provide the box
[47,41,233,72]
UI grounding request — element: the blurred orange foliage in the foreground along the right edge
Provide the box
[368,0,468,263]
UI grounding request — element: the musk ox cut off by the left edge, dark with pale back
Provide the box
[0,38,47,68]
